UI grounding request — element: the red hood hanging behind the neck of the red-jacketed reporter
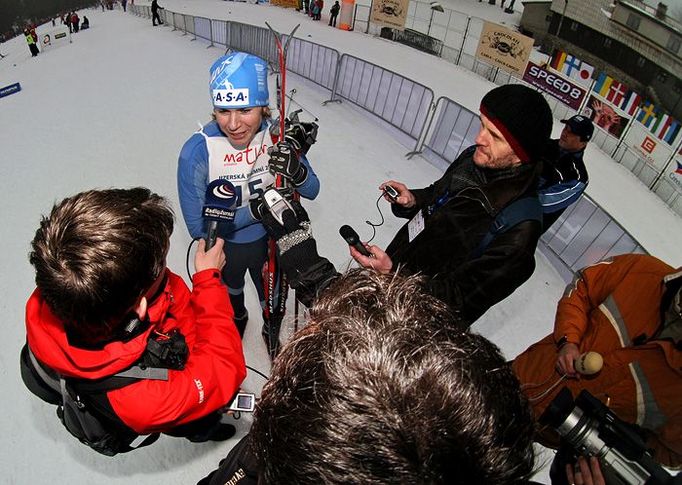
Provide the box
[26,272,175,379]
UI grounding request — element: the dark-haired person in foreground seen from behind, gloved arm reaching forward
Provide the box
[200,202,534,485]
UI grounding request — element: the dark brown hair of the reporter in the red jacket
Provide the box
[29,187,173,343]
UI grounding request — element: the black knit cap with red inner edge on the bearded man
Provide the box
[481,84,554,162]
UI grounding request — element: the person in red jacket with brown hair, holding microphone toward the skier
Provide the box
[21,188,246,454]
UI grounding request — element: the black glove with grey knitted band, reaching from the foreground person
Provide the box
[263,201,338,306]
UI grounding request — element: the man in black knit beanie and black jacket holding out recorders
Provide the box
[351,84,553,324]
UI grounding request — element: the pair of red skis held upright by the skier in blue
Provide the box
[263,22,300,359]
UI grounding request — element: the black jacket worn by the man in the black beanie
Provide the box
[386,147,542,324]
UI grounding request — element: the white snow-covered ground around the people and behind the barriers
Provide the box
[0,0,682,485]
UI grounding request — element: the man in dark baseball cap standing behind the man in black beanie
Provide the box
[539,115,594,231]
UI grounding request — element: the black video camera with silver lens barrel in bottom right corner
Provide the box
[540,387,682,485]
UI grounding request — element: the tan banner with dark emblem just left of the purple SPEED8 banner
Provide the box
[476,22,533,77]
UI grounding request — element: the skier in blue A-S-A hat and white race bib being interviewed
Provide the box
[177,52,320,349]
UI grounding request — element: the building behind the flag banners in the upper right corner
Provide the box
[521,0,682,119]
